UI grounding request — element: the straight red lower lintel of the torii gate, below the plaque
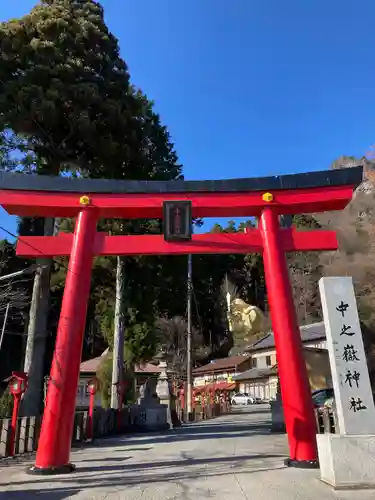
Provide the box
[17,228,338,258]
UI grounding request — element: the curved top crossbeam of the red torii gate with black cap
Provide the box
[0,167,362,219]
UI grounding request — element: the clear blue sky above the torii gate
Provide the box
[0,0,375,235]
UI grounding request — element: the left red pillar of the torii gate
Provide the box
[30,207,98,474]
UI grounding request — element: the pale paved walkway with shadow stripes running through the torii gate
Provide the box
[0,405,375,500]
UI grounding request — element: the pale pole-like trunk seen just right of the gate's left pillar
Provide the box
[111,256,125,410]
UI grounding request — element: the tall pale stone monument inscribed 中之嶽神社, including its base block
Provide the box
[317,277,375,489]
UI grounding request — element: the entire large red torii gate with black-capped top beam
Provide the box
[0,167,362,474]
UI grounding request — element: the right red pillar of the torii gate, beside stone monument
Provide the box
[260,208,317,467]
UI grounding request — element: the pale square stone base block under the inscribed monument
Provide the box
[317,434,375,490]
